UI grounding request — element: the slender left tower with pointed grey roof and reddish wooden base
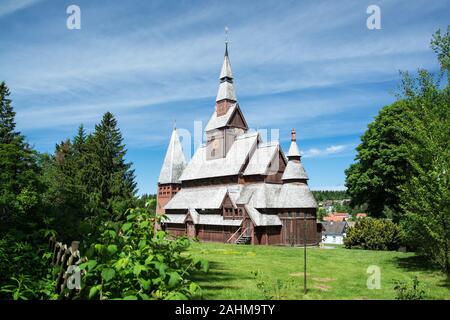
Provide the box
[156,127,186,214]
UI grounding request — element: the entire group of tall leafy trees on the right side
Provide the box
[346,27,450,274]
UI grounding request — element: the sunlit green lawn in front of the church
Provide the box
[190,243,450,299]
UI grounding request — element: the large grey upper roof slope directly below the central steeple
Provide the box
[180,132,259,181]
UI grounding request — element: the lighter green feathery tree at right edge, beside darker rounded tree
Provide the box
[401,71,450,274]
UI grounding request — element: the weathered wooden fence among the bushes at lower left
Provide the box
[49,237,87,297]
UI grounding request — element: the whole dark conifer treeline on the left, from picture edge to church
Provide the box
[0,82,162,299]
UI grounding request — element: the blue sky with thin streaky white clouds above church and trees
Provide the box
[0,0,450,193]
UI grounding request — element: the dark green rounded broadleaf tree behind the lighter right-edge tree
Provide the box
[345,101,410,220]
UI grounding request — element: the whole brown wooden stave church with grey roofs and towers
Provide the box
[157,43,322,245]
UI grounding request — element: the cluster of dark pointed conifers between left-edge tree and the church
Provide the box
[41,112,138,241]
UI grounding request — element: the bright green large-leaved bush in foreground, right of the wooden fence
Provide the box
[80,208,208,300]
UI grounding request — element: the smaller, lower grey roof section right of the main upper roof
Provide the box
[244,141,280,176]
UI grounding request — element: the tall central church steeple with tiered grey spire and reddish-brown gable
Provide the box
[205,37,248,160]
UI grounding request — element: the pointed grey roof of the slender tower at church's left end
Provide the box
[158,128,186,184]
